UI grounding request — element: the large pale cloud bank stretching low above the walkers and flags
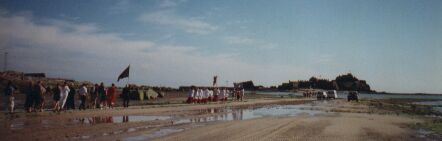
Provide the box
[0,12,308,87]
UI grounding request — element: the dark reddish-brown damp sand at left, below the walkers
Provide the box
[0,99,308,140]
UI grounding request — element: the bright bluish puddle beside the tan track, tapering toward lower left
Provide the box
[122,104,326,141]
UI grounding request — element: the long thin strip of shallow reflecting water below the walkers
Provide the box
[5,104,321,130]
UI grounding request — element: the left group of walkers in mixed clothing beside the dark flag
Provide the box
[4,81,130,113]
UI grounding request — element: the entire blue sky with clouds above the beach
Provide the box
[0,0,442,93]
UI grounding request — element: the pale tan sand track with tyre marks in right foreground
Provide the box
[157,113,422,141]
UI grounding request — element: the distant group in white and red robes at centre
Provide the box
[187,86,244,103]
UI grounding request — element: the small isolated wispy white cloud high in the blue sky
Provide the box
[138,10,218,34]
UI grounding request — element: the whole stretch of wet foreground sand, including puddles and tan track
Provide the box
[0,98,436,141]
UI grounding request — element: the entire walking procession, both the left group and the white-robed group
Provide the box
[4,81,244,113]
